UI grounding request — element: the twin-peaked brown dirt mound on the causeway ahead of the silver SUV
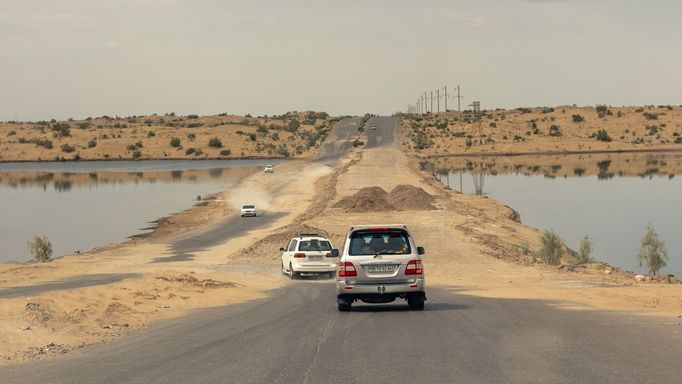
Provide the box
[333,185,435,212]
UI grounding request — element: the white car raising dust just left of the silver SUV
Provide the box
[279,233,339,279]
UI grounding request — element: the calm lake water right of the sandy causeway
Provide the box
[428,154,682,276]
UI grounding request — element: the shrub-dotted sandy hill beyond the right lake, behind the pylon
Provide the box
[401,105,682,156]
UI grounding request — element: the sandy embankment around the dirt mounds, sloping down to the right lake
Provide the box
[308,125,682,316]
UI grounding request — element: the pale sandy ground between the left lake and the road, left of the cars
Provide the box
[0,156,342,363]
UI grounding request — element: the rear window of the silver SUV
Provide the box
[348,229,411,256]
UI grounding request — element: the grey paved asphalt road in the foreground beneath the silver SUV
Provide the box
[0,277,682,384]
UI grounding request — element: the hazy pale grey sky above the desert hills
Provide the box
[0,0,682,120]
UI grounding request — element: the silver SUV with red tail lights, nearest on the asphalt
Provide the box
[336,224,426,311]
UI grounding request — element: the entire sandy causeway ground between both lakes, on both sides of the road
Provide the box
[0,112,682,364]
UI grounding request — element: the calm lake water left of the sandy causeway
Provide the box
[0,160,278,262]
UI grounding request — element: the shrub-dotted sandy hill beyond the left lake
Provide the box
[0,112,332,161]
